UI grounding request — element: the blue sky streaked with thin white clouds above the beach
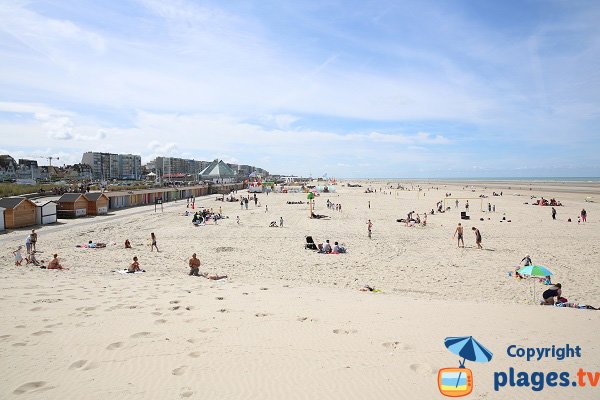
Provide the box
[0,0,600,178]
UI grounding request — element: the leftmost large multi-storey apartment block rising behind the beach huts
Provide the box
[81,151,142,180]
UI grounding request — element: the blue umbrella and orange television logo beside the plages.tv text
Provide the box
[438,336,493,397]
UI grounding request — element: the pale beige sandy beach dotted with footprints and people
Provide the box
[0,181,600,399]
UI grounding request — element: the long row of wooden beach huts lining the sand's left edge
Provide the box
[0,183,242,231]
